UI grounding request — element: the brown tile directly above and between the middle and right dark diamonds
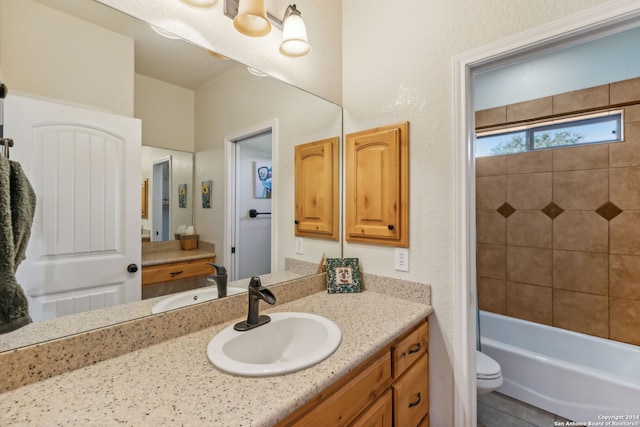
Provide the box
[552,169,609,210]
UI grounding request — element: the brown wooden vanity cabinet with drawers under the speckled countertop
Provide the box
[277,320,429,427]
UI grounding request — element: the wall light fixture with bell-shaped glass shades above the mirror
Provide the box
[224,0,311,57]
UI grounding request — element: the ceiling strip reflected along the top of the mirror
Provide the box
[35,0,238,90]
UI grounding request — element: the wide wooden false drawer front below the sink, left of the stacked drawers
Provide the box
[288,352,391,426]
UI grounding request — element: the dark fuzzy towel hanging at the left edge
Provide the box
[0,156,36,334]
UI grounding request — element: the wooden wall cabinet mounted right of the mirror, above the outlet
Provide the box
[345,122,409,247]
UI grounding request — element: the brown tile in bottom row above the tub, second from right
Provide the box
[553,289,609,338]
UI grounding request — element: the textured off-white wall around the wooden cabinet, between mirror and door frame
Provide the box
[342,0,605,425]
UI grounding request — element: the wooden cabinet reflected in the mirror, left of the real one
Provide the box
[295,137,339,240]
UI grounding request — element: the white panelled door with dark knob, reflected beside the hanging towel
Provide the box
[5,94,141,321]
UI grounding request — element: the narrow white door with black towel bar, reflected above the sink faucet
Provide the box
[234,132,272,280]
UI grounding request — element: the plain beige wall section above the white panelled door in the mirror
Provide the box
[0,0,134,116]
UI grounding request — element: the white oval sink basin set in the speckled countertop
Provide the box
[207,313,342,377]
